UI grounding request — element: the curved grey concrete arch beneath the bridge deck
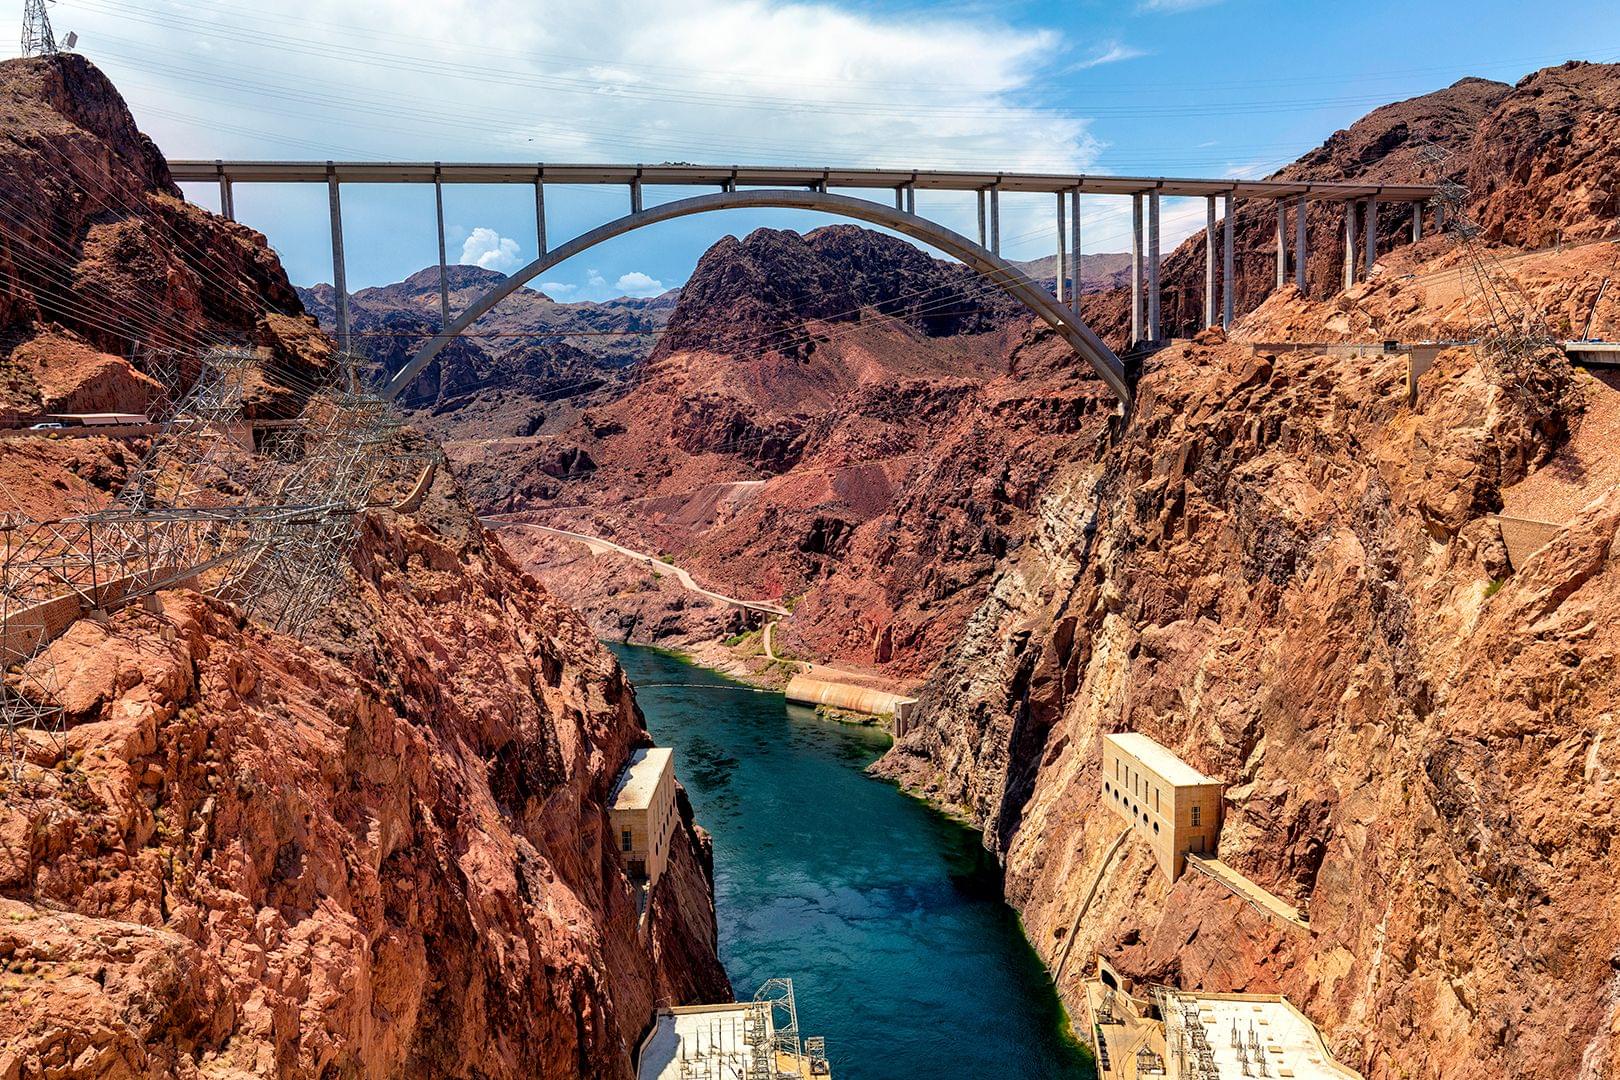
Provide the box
[382,188,1131,402]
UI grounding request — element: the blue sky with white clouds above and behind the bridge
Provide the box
[0,0,1620,300]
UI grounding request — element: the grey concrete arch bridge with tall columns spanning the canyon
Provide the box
[170,160,1435,403]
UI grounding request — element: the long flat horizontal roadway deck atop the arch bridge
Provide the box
[168,160,1435,202]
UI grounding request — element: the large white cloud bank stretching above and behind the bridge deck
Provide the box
[88,0,1127,265]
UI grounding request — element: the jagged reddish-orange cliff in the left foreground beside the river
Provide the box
[0,481,727,1077]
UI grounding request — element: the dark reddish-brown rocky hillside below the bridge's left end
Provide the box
[0,55,327,416]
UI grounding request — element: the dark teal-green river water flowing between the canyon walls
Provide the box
[614,648,1095,1080]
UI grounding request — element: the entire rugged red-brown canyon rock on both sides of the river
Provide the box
[0,31,1620,1080]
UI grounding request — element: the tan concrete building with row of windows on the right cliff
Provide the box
[1103,732,1221,881]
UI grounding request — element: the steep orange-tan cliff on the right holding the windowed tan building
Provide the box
[883,342,1620,1078]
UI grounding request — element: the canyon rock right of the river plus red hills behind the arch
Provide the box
[408,63,1620,1078]
